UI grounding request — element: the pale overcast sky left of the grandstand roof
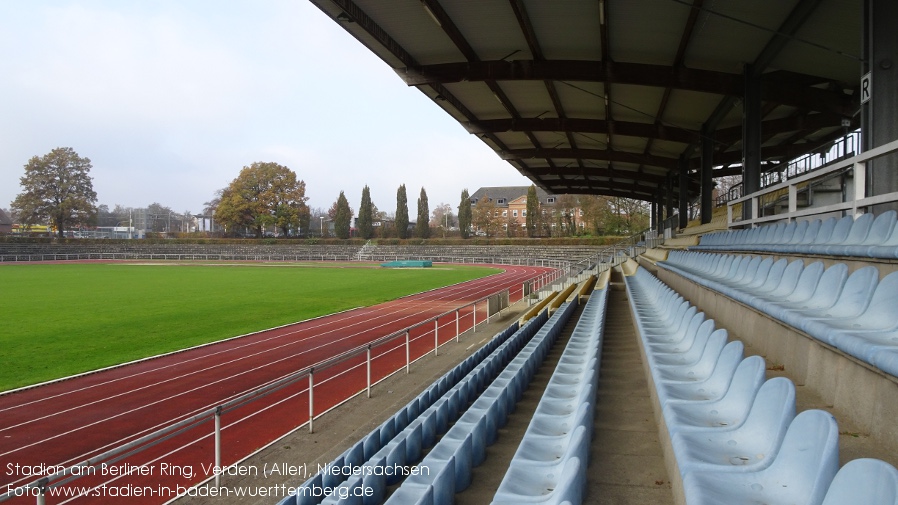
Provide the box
[0,0,530,219]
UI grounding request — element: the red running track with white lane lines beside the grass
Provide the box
[0,266,551,504]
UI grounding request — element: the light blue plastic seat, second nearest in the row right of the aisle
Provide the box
[683,410,836,505]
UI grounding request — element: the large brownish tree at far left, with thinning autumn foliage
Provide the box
[12,147,97,238]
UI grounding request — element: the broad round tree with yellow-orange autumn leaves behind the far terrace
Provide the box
[215,162,308,237]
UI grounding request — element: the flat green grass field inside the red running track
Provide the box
[0,263,496,391]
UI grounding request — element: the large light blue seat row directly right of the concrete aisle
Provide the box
[625,268,898,505]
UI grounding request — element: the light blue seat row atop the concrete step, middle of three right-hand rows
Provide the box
[658,251,898,376]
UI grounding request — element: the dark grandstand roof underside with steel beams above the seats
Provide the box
[311,0,863,200]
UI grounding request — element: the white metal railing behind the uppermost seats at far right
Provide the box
[727,140,898,227]
